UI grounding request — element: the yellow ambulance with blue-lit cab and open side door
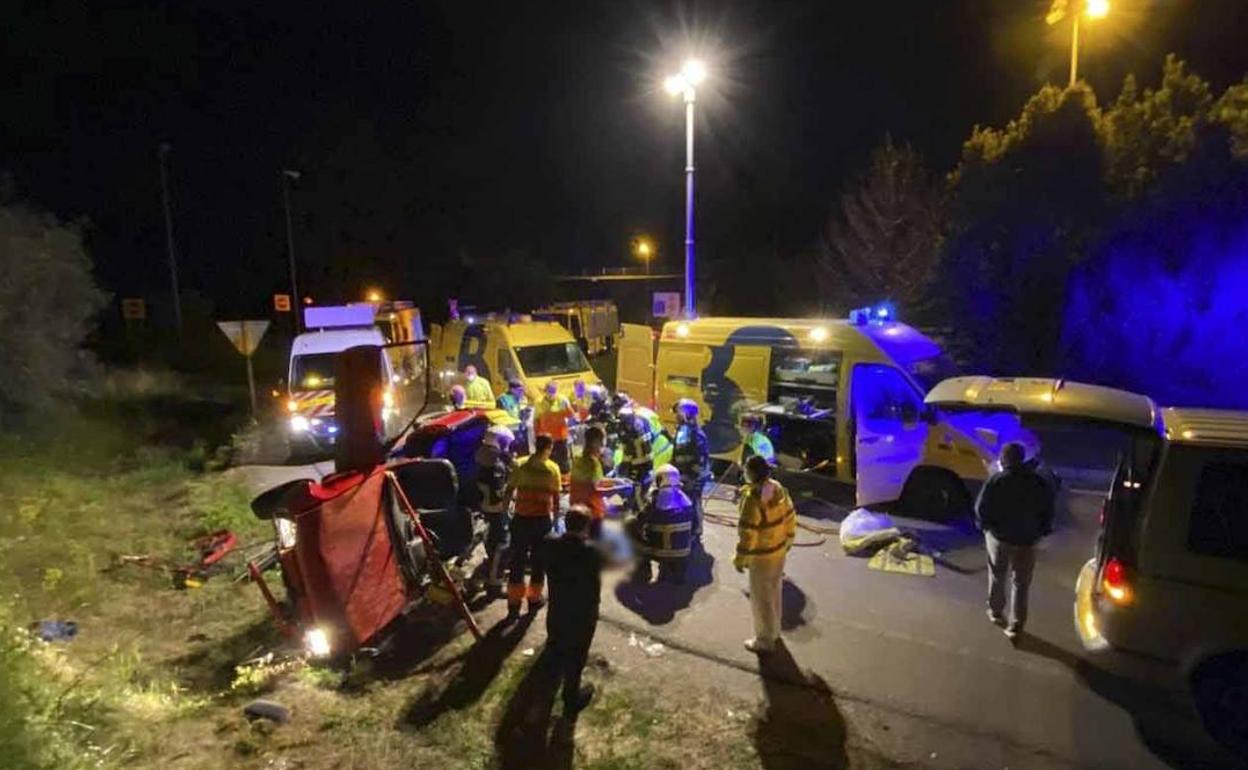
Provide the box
[617,306,1038,519]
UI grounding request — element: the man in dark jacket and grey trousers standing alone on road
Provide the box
[975,443,1055,641]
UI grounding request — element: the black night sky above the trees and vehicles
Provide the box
[0,0,1248,314]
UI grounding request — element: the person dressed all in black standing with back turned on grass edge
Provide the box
[545,505,607,719]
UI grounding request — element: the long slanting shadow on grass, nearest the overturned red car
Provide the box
[399,614,535,729]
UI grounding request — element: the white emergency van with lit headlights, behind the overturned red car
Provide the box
[286,303,409,453]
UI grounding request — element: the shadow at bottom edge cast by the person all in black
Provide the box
[494,648,575,770]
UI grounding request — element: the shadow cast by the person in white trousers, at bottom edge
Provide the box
[753,644,849,770]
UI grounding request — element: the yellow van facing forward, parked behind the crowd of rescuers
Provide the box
[429,316,600,403]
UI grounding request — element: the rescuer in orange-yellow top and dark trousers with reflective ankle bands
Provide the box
[507,436,560,620]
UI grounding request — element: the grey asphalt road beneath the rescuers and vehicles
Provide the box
[240,434,1227,769]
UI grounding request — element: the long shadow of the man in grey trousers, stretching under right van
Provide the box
[1017,634,1244,770]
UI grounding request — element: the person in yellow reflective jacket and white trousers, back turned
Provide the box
[733,454,797,653]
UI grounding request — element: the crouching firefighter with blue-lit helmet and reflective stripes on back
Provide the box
[629,464,694,583]
